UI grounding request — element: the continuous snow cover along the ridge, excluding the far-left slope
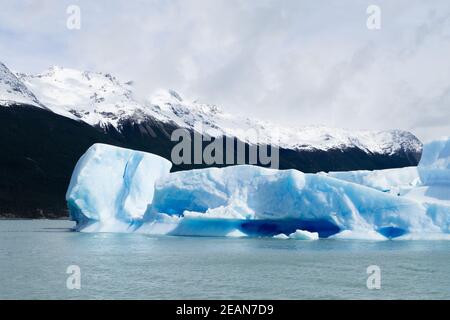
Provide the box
[18,67,422,154]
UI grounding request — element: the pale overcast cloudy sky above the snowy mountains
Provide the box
[0,0,450,141]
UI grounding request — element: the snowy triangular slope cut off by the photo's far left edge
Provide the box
[0,62,41,107]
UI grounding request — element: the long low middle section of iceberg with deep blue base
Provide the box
[145,165,440,236]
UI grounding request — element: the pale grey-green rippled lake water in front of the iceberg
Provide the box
[0,220,450,299]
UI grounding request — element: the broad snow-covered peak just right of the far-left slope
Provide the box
[19,66,149,127]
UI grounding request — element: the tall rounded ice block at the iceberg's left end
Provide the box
[66,144,172,231]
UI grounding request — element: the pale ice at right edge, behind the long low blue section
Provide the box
[321,138,450,239]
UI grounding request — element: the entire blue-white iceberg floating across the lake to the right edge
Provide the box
[66,140,450,240]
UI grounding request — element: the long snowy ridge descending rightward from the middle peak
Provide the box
[150,91,422,154]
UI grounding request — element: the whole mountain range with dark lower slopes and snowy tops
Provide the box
[0,64,422,218]
